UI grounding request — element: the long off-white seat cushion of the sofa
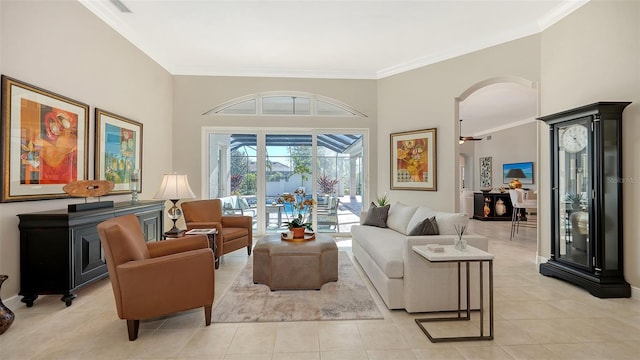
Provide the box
[351,225,406,279]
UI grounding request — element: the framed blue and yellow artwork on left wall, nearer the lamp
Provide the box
[94,109,142,194]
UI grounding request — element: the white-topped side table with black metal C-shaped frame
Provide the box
[412,245,493,343]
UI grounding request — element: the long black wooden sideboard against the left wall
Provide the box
[18,201,164,307]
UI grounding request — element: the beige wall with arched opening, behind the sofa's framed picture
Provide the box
[377,35,540,211]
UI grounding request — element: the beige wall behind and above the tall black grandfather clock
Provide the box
[538,0,640,290]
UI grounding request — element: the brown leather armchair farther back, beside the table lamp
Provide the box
[181,199,253,268]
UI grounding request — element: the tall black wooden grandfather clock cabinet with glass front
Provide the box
[539,102,631,298]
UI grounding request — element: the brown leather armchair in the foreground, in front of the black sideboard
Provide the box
[98,214,215,341]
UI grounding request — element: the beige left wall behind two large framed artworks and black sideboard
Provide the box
[0,1,172,298]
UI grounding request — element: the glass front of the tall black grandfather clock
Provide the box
[556,117,592,268]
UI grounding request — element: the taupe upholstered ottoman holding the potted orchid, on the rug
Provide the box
[253,234,338,290]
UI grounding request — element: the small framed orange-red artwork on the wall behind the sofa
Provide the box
[391,129,437,191]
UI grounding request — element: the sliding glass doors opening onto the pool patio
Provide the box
[207,129,366,234]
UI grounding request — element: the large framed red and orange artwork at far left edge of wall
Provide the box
[0,75,89,202]
